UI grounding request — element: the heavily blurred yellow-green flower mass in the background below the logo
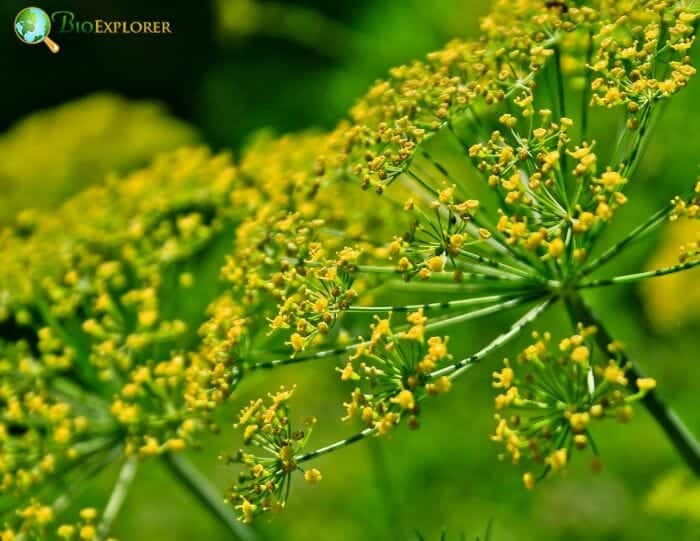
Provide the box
[0,94,199,223]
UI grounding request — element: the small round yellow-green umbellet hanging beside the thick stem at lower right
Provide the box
[491,327,656,489]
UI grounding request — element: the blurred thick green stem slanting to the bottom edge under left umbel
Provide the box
[163,453,259,541]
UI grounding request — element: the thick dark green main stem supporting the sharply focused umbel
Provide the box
[565,293,700,476]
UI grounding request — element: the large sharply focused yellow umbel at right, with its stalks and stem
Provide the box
[213,0,700,520]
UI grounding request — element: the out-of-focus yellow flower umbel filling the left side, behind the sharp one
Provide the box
[0,148,246,540]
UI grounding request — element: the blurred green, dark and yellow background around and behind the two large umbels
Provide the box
[0,0,700,541]
